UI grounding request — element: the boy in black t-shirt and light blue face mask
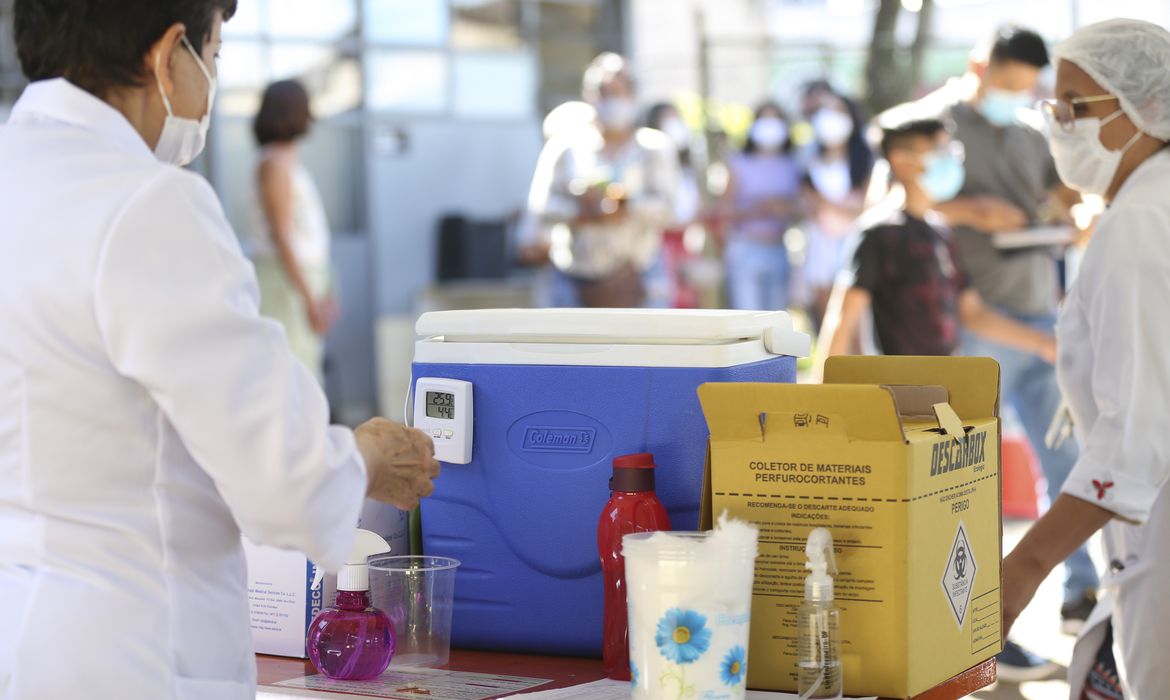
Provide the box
[821,105,1055,362]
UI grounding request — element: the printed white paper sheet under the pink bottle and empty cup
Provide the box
[269,668,552,700]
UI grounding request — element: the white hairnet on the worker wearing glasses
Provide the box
[1054,20,1170,140]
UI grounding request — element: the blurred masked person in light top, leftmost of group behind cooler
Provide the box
[529,54,679,308]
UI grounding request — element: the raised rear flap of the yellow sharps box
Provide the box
[825,356,999,421]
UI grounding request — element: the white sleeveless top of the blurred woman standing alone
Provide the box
[247,149,329,268]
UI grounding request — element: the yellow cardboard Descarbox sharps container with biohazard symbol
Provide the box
[698,357,1003,698]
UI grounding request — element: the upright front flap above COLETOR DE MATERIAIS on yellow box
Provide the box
[698,383,906,441]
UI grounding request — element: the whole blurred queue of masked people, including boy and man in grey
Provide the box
[507,27,1100,680]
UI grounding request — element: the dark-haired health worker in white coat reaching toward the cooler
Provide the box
[0,0,439,700]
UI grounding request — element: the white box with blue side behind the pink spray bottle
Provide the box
[243,500,411,659]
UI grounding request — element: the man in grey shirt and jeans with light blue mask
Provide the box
[923,26,1099,682]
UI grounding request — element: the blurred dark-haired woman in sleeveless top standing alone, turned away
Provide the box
[250,81,339,383]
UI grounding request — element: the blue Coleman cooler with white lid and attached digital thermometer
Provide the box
[411,309,810,656]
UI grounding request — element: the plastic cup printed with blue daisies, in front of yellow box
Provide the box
[622,526,757,700]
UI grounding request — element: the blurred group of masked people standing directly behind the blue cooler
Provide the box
[519,54,875,327]
